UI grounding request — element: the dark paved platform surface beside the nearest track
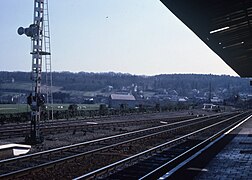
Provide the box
[196,115,252,180]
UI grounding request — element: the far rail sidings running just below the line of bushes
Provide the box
[0,112,198,139]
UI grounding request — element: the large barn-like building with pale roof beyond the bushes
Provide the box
[109,94,137,109]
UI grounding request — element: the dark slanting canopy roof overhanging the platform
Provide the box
[161,0,252,77]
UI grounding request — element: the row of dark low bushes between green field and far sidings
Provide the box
[0,104,189,124]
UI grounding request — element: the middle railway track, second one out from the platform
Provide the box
[0,113,241,179]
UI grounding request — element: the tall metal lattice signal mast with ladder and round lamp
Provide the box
[18,0,53,144]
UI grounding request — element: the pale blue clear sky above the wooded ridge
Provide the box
[0,0,238,76]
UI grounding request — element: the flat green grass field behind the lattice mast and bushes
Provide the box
[0,104,99,114]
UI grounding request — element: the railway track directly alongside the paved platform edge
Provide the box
[75,112,251,180]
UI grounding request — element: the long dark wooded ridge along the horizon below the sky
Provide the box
[0,72,251,95]
